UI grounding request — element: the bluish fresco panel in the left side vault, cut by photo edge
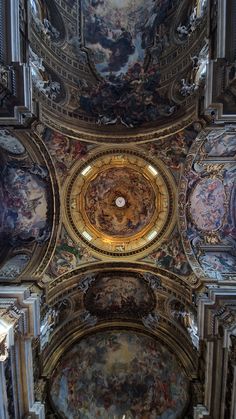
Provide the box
[0,164,49,243]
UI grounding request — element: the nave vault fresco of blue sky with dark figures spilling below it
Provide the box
[77,0,181,128]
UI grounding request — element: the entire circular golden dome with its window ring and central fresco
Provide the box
[65,149,175,259]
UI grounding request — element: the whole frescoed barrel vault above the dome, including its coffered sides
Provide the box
[29,0,206,137]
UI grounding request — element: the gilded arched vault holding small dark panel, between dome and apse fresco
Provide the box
[41,261,198,376]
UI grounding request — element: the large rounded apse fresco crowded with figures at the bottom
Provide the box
[50,331,188,419]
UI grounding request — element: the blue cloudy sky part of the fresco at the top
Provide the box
[82,0,164,76]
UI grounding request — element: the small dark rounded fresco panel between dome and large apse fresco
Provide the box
[85,273,155,317]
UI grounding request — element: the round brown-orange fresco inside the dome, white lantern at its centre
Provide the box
[85,167,156,237]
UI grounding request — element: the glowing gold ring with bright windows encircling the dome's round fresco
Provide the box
[62,146,176,260]
